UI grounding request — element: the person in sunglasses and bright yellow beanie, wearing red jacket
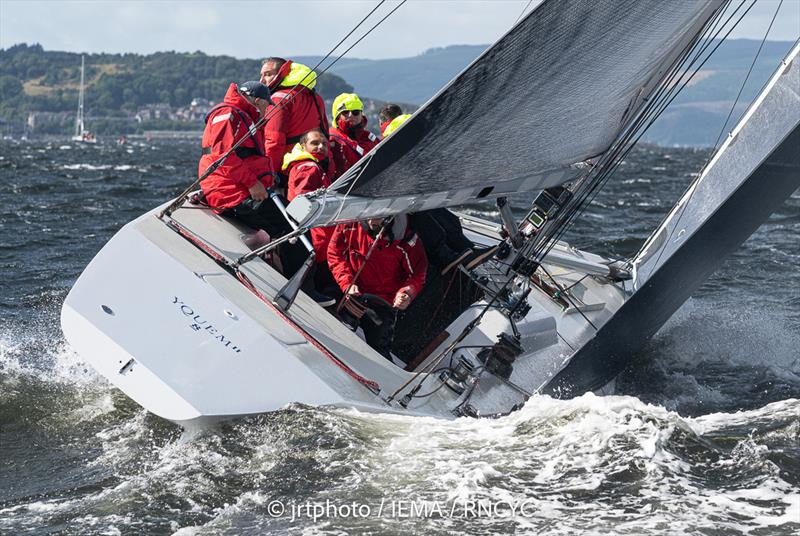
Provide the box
[330,93,381,178]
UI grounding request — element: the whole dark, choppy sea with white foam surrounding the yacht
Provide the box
[0,140,800,535]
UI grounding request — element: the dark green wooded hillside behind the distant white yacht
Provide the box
[0,44,353,134]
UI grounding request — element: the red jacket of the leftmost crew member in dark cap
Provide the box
[197,84,272,212]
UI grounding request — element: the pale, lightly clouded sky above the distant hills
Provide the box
[0,0,800,59]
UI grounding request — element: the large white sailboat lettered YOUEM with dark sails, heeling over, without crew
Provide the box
[61,0,800,427]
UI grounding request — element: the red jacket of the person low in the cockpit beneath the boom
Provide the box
[328,215,428,303]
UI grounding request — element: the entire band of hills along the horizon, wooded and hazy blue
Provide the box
[0,39,792,146]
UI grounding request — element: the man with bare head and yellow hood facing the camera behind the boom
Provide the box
[283,128,339,295]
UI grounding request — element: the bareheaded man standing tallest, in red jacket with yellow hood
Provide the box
[261,58,329,176]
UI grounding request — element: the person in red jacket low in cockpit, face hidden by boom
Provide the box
[328,214,428,359]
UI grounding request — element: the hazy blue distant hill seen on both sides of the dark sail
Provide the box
[298,39,793,146]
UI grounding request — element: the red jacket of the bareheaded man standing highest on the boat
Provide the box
[264,86,328,173]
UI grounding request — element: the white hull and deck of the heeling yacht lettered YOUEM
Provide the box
[61,199,622,425]
